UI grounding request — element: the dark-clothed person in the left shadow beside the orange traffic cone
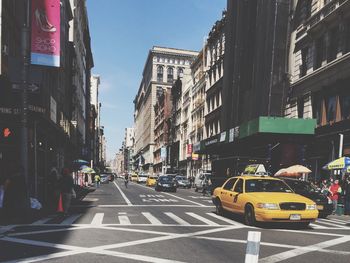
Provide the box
[60,168,75,216]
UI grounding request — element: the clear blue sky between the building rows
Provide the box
[87,0,226,159]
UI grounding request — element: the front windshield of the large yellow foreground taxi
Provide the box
[245,179,292,193]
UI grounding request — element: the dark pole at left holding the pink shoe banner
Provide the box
[20,0,30,192]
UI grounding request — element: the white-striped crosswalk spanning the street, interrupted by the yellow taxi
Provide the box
[32,211,350,229]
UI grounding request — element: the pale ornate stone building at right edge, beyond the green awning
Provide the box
[285,0,350,177]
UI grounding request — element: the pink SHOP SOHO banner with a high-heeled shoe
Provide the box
[31,0,61,67]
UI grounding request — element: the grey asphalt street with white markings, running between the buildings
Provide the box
[0,179,350,263]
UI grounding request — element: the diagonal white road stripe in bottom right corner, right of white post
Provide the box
[259,236,350,263]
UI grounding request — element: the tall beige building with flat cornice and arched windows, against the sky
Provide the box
[134,47,198,173]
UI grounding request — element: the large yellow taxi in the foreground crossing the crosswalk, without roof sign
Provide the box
[212,175,318,226]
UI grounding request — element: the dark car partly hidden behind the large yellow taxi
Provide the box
[280,177,333,218]
